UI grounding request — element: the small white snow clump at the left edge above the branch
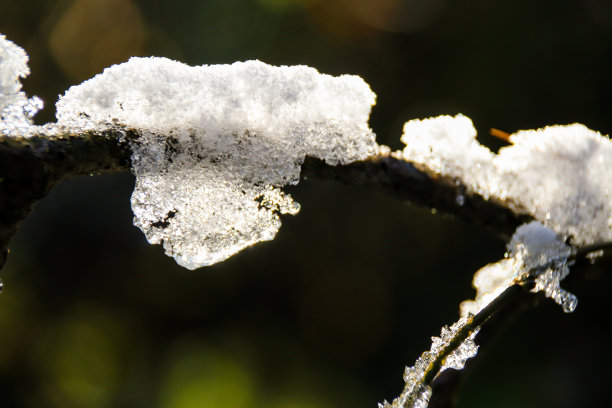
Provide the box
[0,34,42,136]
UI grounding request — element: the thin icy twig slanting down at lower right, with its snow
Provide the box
[379,221,612,408]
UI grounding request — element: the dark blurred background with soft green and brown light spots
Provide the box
[0,0,612,408]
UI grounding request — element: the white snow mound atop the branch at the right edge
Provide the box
[402,115,612,246]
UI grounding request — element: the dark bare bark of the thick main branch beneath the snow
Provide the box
[0,126,532,268]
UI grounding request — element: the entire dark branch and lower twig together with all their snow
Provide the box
[0,35,612,408]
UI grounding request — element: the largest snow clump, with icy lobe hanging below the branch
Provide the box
[57,58,379,269]
